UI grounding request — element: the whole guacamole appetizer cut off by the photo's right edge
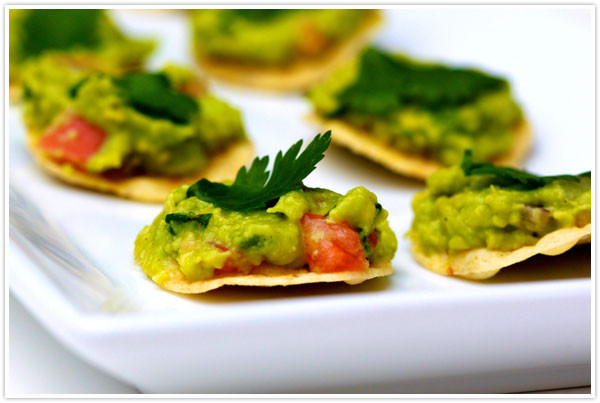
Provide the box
[408,151,591,279]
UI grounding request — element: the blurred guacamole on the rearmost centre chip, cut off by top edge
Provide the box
[191,9,372,66]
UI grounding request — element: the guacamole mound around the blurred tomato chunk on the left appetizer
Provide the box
[24,56,246,176]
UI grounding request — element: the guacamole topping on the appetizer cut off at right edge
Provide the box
[408,163,591,255]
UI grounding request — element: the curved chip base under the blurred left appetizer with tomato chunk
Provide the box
[27,135,254,203]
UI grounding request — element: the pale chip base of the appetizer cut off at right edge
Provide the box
[411,224,592,280]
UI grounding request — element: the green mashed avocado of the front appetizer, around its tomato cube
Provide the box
[134,185,397,284]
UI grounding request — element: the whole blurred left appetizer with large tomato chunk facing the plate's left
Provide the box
[23,56,253,202]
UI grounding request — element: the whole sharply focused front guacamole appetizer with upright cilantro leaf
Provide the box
[134,133,397,293]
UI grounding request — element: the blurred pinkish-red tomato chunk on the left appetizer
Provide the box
[38,116,106,167]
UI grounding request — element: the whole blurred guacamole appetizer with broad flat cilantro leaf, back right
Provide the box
[308,47,530,179]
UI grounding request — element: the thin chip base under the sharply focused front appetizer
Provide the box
[162,262,393,294]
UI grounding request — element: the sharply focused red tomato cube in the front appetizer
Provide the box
[300,213,369,273]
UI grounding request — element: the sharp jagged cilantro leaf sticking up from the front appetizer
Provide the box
[187,131,331,211]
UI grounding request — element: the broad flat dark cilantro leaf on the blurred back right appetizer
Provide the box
[333,47,508,115]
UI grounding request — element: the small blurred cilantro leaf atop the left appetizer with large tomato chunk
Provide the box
[114,73,200,124]
